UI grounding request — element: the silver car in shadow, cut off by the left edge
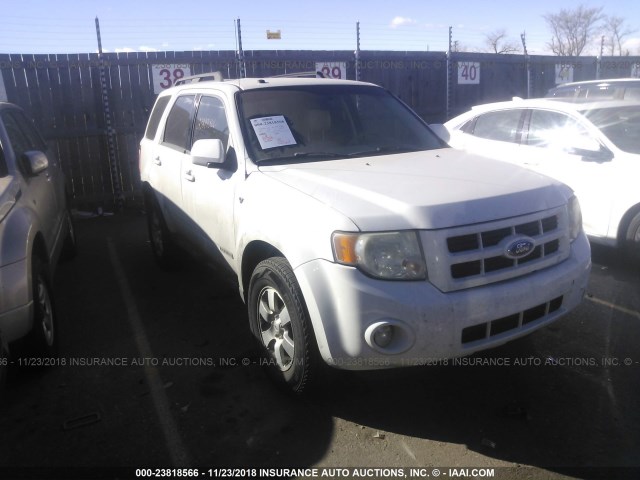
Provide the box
[0,102,75,362]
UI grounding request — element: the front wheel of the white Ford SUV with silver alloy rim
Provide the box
[247,257,320,394]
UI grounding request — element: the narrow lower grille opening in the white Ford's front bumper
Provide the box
[461,296,562,345]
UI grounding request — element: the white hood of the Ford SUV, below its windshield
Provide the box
[260,148,570,231]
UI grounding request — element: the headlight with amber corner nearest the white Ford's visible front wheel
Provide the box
[332,231,427,280]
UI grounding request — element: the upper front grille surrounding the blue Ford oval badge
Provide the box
[422,207,570,292]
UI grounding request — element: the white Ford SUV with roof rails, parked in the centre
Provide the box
[140,78,591,392]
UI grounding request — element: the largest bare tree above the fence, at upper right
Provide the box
[543,5,604,57]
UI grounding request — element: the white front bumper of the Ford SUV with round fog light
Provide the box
[295,234,591,370]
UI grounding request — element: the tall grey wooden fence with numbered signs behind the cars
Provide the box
[0,51,640,210]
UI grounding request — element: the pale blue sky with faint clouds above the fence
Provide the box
[0,0,640,55]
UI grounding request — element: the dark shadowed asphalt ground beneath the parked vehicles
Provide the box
[0,212,640,479]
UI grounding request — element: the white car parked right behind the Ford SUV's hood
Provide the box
[434,95,640,258]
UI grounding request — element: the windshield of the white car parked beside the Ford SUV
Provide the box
[583,105,640,153]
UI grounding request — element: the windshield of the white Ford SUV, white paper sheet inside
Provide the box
[238,85,447,163]
